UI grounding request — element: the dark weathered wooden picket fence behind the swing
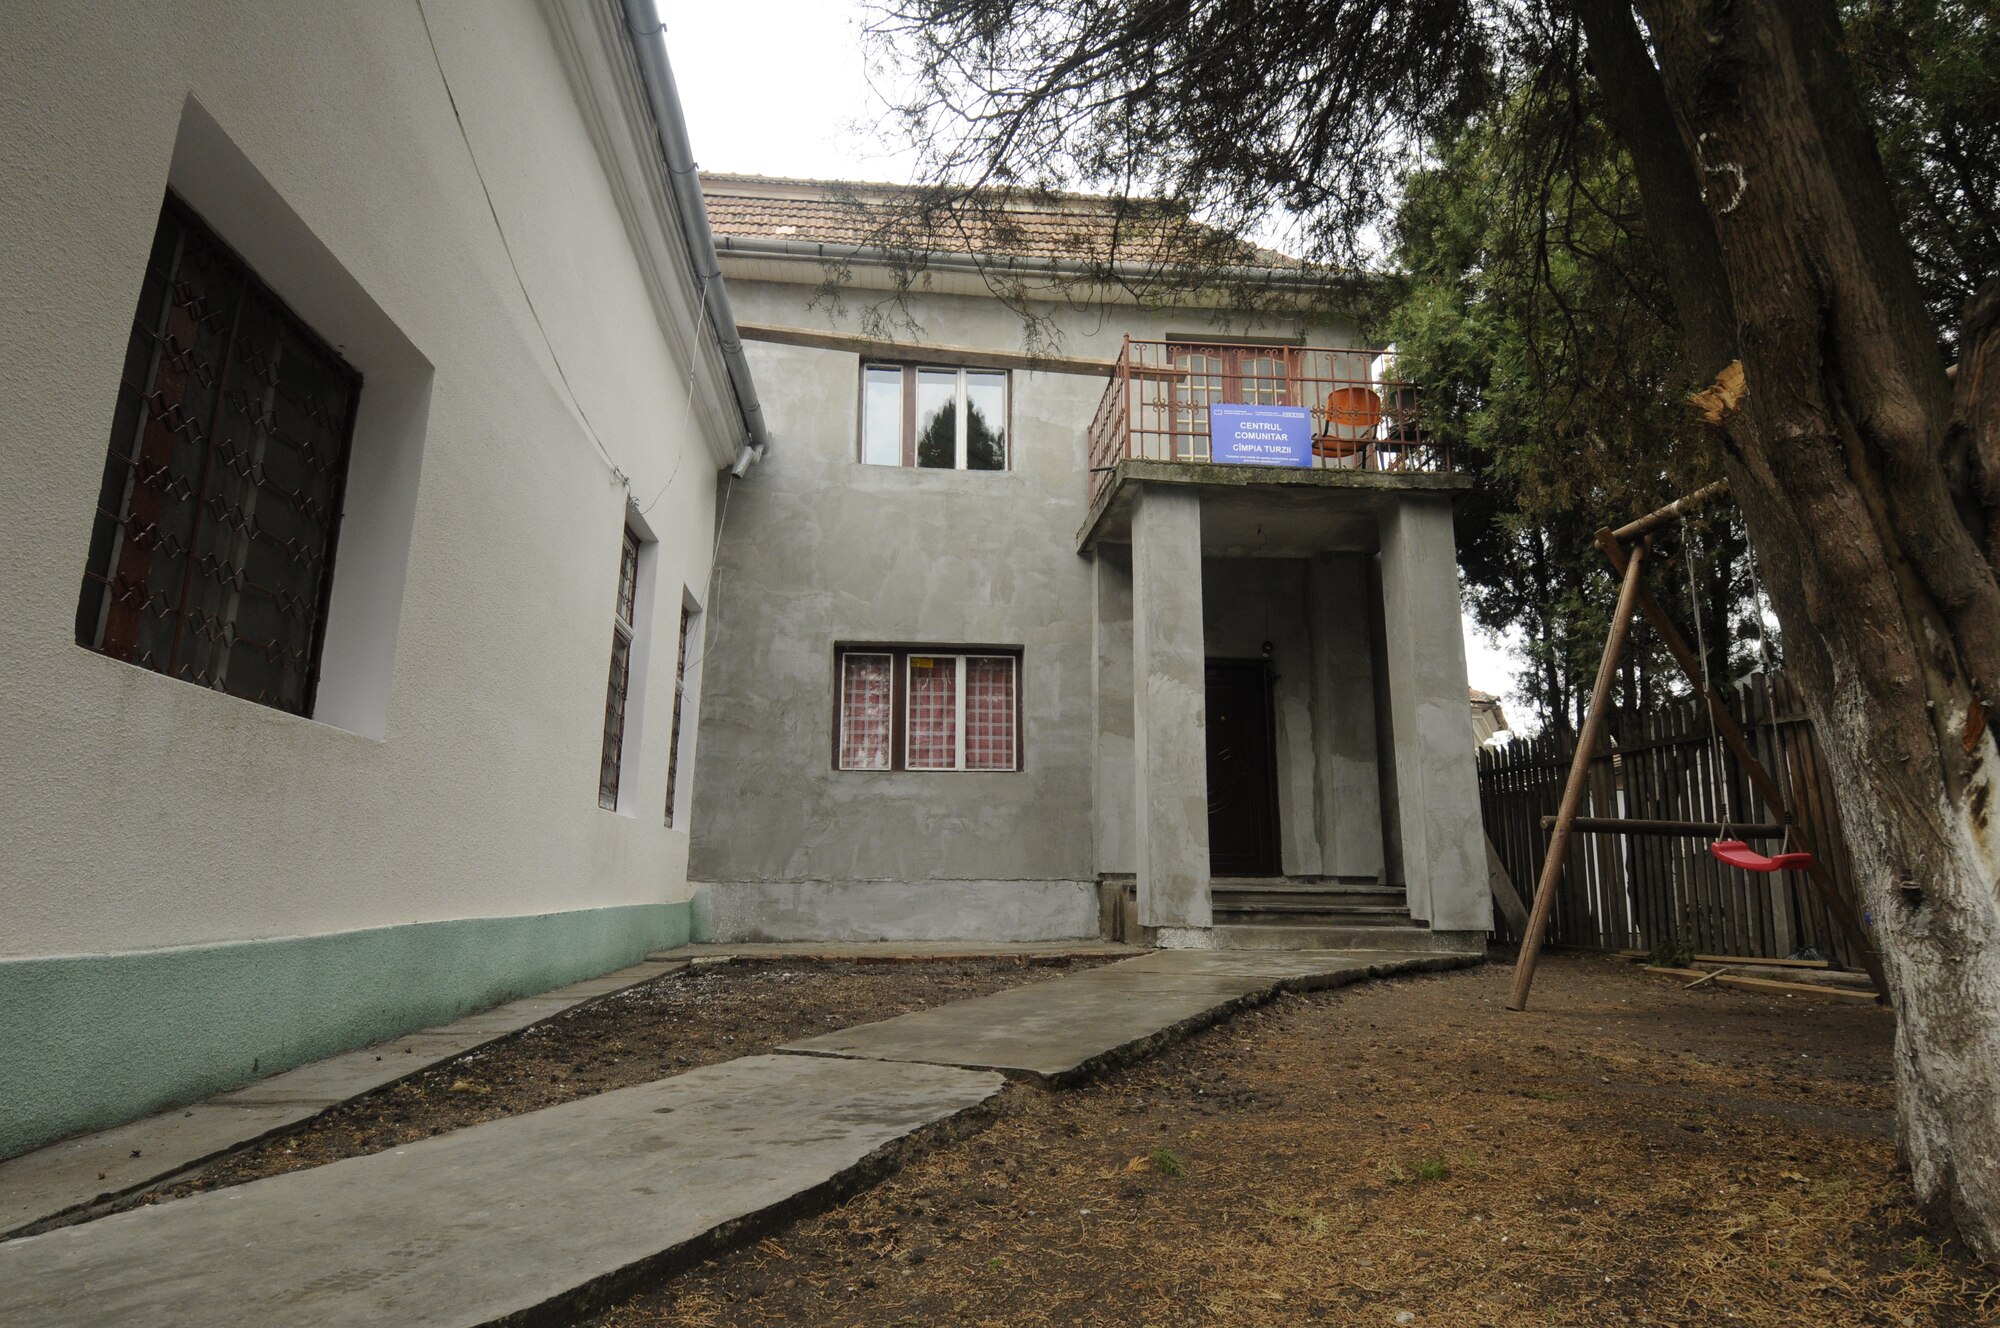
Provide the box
[1480,674,1862,964]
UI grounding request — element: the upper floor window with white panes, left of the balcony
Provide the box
[862,364,1008,470]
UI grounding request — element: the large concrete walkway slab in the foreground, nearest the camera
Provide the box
[0,1056,1002,1328]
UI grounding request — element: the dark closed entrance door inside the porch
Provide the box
[1208,660,1280,876]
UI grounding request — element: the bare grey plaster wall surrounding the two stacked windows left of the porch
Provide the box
[690,282,1112,938]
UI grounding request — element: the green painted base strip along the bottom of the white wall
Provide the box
[0,902,692,1158]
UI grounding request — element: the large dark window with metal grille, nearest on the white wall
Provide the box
[76,194,362,714]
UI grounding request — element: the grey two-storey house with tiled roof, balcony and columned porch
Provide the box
[690,176,1490,948]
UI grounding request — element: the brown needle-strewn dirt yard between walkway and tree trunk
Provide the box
[590,956,2000,1328]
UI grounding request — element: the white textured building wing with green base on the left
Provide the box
[0,0,746,1156]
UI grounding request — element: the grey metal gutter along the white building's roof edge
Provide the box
[624,0,770,476]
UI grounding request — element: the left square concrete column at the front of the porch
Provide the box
[1132,488,1212,932]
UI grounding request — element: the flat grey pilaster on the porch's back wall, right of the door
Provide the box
[1306,554,1382,880]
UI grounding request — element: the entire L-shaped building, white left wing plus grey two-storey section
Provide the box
[0,0,1490,1158]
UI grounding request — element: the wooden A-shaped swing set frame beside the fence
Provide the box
[1506,480,1888,1010]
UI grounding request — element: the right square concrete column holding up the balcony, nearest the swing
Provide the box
[1380,496,1492,932]
